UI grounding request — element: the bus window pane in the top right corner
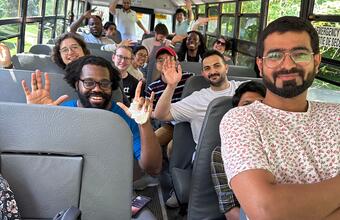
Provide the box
[313,0,340,15]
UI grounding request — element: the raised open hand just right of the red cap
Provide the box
[162,57,182,86]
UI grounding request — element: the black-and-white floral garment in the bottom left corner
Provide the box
[0,174,21,220]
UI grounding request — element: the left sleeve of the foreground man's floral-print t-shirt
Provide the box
[220,106,271,185]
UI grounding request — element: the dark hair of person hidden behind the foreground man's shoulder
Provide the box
[231,81,266,107]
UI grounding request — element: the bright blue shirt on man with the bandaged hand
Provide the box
[61,100,141,160]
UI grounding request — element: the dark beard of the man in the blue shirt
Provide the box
[77,90,112,109]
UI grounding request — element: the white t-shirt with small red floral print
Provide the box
[220,101,340,184]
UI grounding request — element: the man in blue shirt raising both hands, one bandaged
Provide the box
[22,56,162,175]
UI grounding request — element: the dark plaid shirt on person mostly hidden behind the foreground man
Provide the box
[211,146,240,213]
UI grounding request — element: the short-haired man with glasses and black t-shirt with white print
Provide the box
[112,46,144,102]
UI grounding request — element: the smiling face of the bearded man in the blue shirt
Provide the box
[76,64,112,109]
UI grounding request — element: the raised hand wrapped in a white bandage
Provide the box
[117,81,155,124]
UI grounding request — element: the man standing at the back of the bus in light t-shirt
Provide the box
[109,0,150,42]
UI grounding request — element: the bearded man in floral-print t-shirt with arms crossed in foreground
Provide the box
[220,17,340,219]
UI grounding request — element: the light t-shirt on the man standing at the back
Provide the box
[115,9,138,42]
